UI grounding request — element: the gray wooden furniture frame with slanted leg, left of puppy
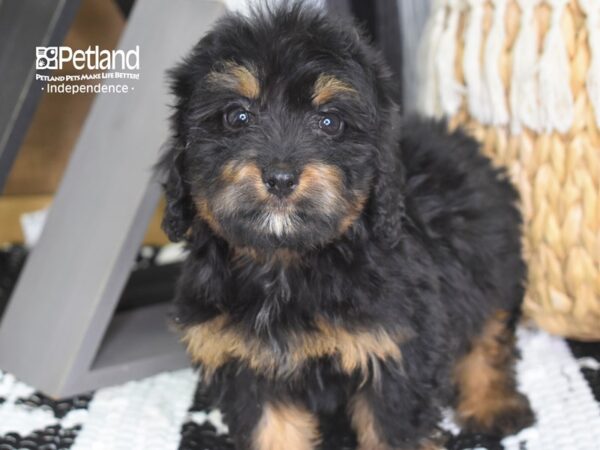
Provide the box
[0,0,225,397]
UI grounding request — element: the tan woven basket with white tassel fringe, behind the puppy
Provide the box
[419,0,600,340]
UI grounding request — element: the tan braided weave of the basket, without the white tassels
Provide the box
[422,0,600,340]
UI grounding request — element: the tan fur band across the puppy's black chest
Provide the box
[183,314,405,379]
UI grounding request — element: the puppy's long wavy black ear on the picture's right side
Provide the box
[371,55,405,248]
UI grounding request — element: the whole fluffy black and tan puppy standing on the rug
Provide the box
[159,5,533,450]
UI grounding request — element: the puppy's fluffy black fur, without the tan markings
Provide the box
[158,5,530,450]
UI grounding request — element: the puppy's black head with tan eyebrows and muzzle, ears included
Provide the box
[159,5,402,250]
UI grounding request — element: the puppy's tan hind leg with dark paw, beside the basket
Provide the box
[455,311,533,433]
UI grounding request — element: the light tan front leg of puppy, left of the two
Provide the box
[253,404,320,450]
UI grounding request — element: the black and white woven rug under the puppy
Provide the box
[0,329,600,450]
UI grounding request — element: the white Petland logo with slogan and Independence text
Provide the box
[35,45,140,94]
